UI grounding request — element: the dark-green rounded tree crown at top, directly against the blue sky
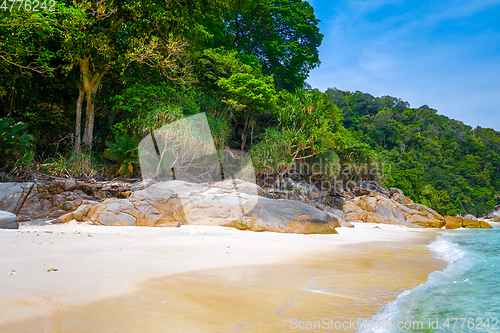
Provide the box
[213,0,323,90]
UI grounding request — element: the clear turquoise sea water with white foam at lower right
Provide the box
[358,228,500,333]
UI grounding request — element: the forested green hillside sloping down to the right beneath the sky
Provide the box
[327,89,500,216]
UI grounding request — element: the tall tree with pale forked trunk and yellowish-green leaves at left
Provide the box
[63,0,203,151]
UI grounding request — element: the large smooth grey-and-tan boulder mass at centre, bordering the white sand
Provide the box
[58,180,340,234]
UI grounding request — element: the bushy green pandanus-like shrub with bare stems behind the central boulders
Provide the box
[250,90,380,184]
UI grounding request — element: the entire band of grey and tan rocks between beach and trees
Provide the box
[0,177,494,234]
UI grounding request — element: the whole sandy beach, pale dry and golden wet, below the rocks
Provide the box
[0,223,446,332]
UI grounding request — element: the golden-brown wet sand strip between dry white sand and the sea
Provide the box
[0,226,445,332]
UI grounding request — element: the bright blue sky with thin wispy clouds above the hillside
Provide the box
[307,0,500,131]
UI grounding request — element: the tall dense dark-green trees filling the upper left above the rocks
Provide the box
[0,0,322,159]
